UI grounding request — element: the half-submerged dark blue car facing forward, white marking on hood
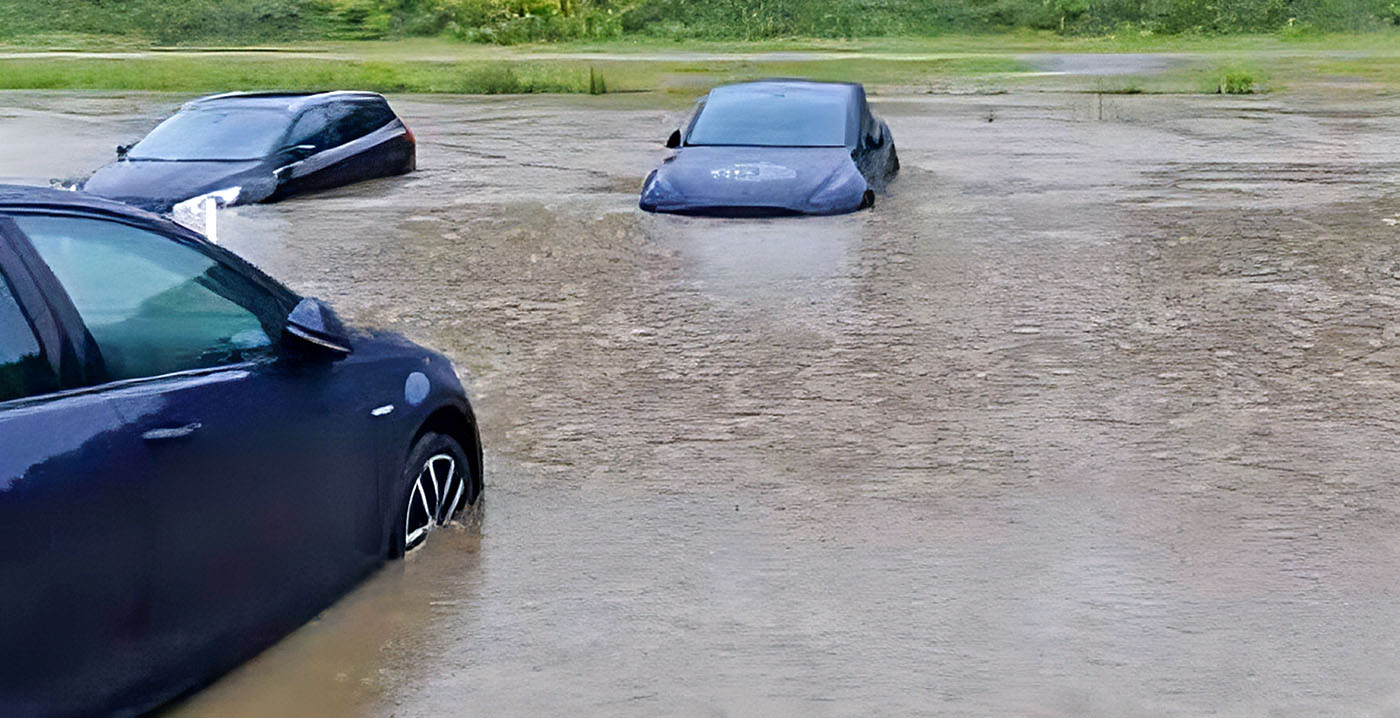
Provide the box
[641,80,899,216]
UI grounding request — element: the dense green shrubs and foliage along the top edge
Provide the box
[0,0,1400,43]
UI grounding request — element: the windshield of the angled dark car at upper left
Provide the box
[127,108,291,160]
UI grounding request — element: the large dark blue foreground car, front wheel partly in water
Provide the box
[0,186,482,717]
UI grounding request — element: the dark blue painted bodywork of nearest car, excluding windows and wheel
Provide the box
[0,186,482,717]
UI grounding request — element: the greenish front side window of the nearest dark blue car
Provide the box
[15,216,283,379]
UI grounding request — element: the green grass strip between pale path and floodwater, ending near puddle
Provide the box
[0,48,1028,94]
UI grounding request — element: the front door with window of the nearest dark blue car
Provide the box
[15,216,382,677]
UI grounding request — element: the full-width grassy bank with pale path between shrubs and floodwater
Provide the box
[0,34,1400,95]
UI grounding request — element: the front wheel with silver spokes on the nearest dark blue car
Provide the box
[389,434,477,558]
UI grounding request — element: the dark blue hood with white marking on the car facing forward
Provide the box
[641,147,869,214]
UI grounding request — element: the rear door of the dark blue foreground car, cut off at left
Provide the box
[0,216,154,715]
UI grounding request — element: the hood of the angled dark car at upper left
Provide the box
[81,160,277,211]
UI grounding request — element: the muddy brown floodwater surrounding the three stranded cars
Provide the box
[0,91,1400,717]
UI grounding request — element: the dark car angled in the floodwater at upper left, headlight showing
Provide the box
[81,92,417,213]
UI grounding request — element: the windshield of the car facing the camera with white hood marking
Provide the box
[686,92,847,147]
